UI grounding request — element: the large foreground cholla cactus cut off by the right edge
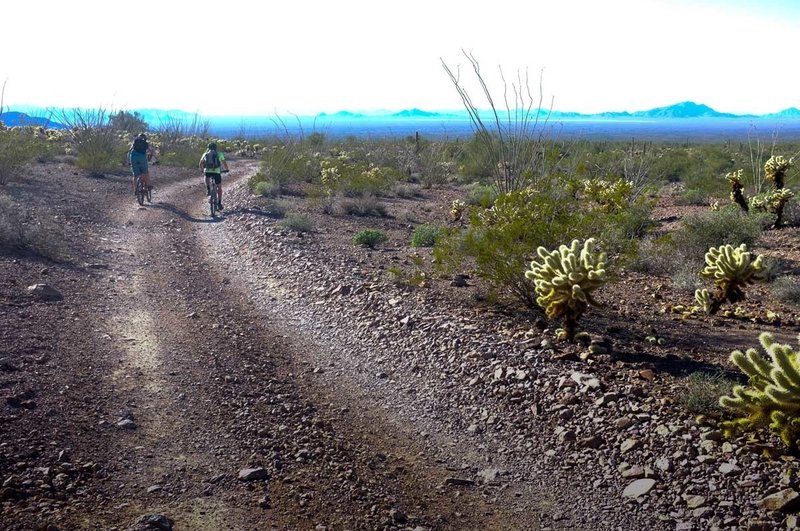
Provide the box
[719,332,800,449]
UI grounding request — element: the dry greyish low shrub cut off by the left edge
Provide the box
[0,195,65,260]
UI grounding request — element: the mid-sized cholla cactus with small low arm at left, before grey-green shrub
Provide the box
[694,244,767,315]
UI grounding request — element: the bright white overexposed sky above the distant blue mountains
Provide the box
[0,0,800,116]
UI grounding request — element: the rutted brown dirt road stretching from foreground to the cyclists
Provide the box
[73,166,528,529]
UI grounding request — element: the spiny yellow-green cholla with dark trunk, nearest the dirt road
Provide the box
[525,238,606,341]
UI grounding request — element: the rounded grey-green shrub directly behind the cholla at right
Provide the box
[671,205,769,266]
